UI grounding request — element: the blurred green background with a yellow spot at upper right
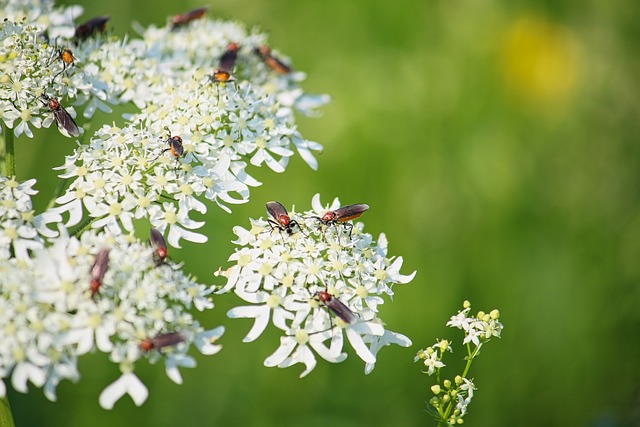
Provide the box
[10,0,640,427]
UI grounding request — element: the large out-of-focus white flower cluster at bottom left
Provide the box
[0,232,224,409]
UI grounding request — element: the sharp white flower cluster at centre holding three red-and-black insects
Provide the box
[219,195,415,377]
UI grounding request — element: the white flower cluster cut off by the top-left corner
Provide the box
[0,0,99,138]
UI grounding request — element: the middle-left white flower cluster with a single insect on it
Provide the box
[55,122,254,247]
